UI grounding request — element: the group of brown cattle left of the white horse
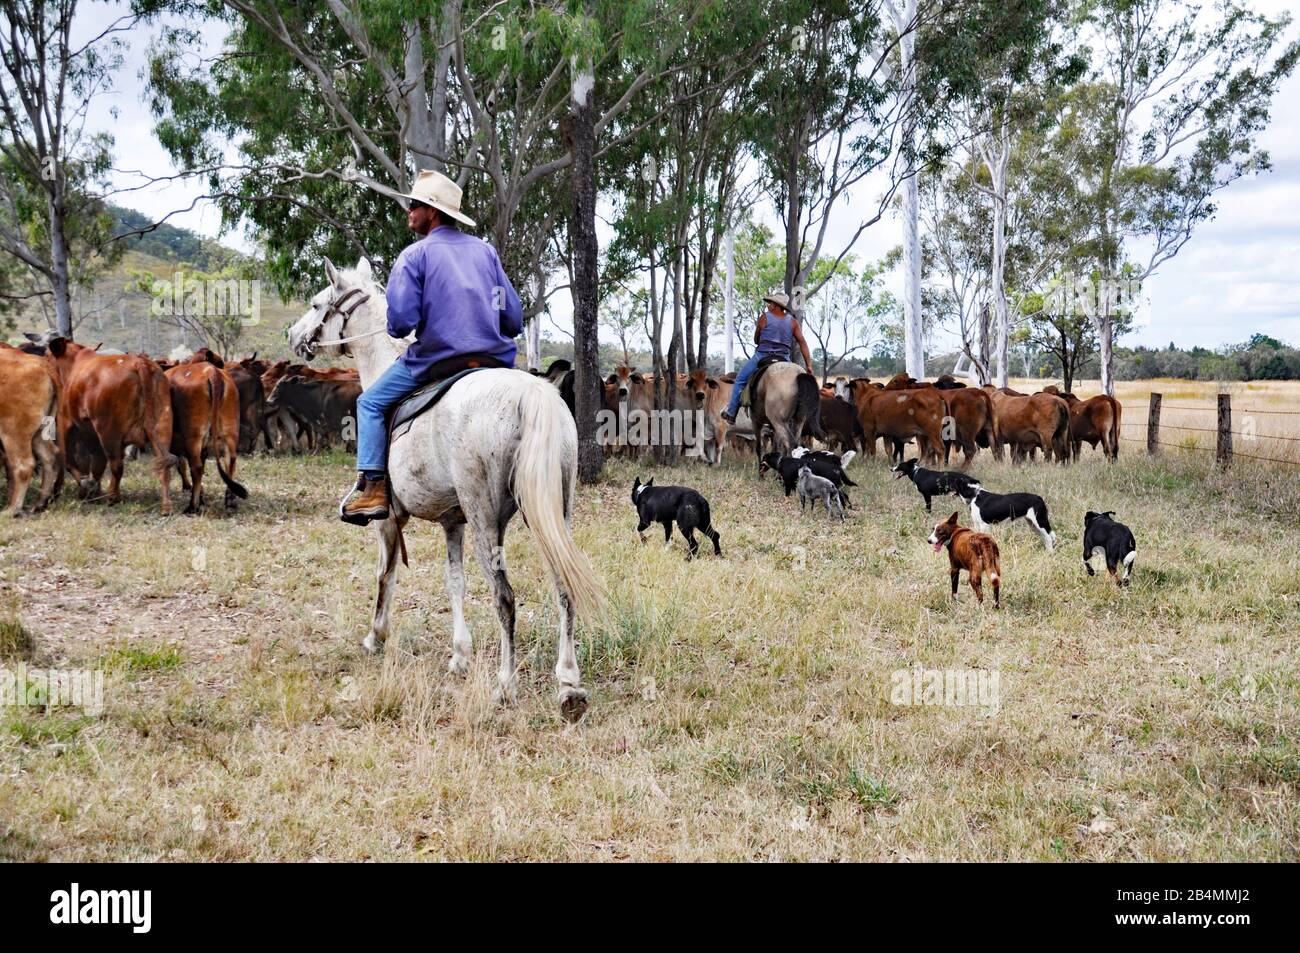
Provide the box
[0,337,361,516]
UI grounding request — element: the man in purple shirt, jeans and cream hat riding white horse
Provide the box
[339,172,523,525]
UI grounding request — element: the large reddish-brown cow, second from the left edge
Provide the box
[48,337,177,516]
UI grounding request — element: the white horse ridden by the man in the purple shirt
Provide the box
[289,259,605,722]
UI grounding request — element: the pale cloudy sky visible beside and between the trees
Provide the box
[91,0,1300,350]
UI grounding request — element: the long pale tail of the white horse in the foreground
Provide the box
[515,381,606,621]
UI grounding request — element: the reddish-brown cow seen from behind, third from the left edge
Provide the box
[166,354,248,514]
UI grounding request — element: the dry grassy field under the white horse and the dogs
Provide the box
[0,382,1300,861]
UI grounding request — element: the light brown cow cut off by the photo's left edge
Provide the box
[0,345,64,516]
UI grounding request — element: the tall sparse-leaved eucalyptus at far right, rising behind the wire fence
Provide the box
[1060,0,1300,394]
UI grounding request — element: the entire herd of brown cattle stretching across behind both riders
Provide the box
[0,337,1121,515]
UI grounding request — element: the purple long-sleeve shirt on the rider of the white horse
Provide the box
[387,226,524,377]
